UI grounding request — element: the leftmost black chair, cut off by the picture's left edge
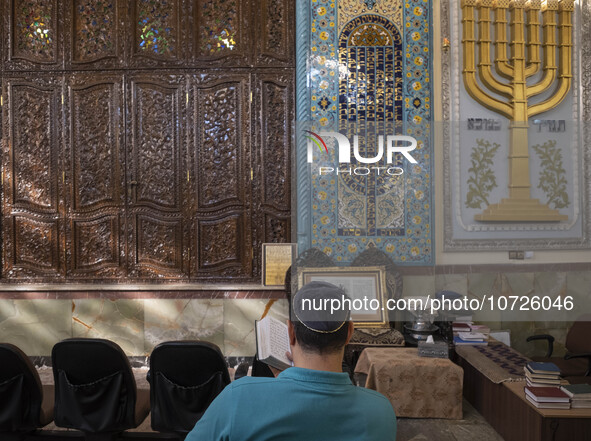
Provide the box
[0,343,53,441]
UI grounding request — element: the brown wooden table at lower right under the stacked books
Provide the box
[457,348,591,441]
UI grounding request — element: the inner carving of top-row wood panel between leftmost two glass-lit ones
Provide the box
[74,0,115,61]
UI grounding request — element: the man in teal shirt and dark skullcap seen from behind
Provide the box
[186,282,396,441]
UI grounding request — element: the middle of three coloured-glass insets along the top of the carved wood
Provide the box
[137,0,174,55]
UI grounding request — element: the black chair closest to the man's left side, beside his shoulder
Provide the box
[148,340,230,438]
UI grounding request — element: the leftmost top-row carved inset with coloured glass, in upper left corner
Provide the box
[15,0,55,61]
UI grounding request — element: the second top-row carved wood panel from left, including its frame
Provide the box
[64,0,129,69]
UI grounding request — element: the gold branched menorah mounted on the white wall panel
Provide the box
[461,0,574,222]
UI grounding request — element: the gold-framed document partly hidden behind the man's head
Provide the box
[298,266,389,328]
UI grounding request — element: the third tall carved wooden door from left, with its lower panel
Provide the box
[127,75,189,278]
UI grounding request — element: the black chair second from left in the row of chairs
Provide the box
[51,338,150,440]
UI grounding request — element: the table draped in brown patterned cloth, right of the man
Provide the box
[355,348,463,419]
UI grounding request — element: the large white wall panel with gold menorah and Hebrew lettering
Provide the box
[441,0,591,251]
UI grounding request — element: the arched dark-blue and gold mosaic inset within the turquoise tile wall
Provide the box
[338,15,404,236]
